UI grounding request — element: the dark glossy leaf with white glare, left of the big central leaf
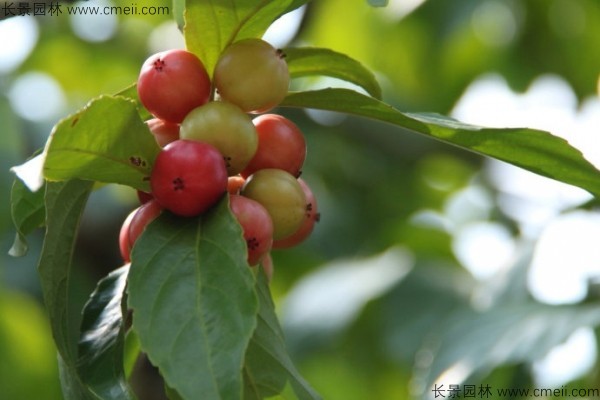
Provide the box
[77,265,134,400]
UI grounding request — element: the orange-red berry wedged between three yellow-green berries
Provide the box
[242,114,306,177]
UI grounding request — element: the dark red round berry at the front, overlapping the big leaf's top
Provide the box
[150,140,227,217]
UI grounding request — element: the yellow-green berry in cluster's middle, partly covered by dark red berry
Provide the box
[180,101,258,175]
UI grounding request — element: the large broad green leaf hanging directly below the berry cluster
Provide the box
[128,197,258,400]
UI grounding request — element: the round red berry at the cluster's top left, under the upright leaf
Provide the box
[137,49,211,123]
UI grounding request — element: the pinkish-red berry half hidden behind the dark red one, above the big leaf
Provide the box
[229,195,273,265]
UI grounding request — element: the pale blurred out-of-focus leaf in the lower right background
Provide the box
[417,302,600,388]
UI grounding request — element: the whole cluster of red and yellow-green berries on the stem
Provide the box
[119,39,319,278]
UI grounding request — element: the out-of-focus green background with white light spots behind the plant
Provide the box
[0,0,600,400]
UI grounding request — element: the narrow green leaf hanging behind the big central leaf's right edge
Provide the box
[244,269,321,400]
